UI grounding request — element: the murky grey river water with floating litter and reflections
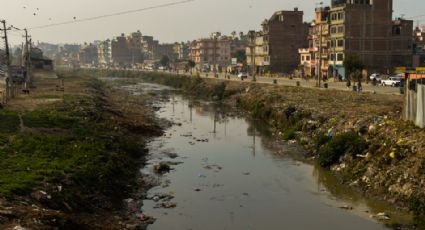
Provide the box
[128,82,407,230]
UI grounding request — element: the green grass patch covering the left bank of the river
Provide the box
[0,90,144,198]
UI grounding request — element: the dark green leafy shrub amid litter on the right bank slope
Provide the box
[318,132,366,167]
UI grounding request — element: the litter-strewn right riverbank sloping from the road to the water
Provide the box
[77,68,425,228]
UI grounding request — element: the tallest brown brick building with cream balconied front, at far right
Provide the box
[329,0,413,73]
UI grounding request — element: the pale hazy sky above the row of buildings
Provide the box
[0,0,425,44]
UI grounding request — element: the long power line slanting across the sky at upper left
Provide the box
[28,0,195,30]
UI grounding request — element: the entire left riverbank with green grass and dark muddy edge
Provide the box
[0,73,161,229]
